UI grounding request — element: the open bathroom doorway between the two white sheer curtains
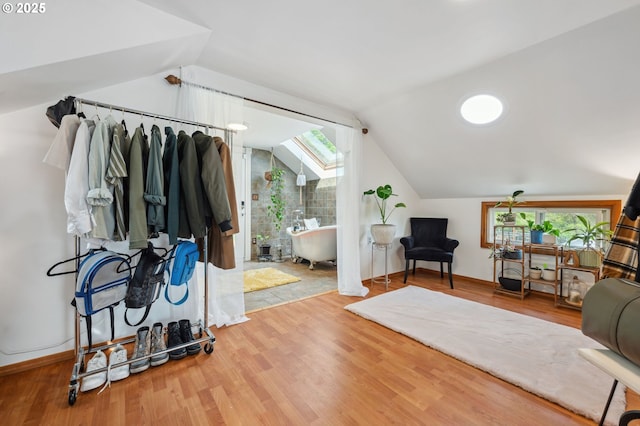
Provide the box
[241,104,338,312]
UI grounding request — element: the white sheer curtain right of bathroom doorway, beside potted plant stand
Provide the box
[336,124,369,296]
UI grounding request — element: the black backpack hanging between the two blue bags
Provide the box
[124,244,165,327]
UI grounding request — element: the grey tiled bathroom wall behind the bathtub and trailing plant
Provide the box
[251,149,336,259]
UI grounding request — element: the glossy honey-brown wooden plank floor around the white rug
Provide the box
[0,271,624,426]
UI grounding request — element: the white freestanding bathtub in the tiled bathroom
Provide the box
[287,225,338,269]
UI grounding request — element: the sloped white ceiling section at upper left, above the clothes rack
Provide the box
[0,0,210,113]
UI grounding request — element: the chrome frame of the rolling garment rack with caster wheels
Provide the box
[68,98,228,406]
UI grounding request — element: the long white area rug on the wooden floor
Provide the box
[345,286,625,424]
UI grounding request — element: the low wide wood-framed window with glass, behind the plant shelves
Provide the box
[480,200,622,248]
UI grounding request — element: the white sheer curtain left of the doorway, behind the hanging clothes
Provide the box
[176,84,248,327]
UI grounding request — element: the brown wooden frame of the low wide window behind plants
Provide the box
[480,200,622,248]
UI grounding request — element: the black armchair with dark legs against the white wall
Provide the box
[400,217,460,288]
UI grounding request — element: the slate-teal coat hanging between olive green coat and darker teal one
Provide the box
[144,124,167,238]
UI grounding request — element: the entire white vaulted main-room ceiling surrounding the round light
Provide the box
[0,0,640,198]
